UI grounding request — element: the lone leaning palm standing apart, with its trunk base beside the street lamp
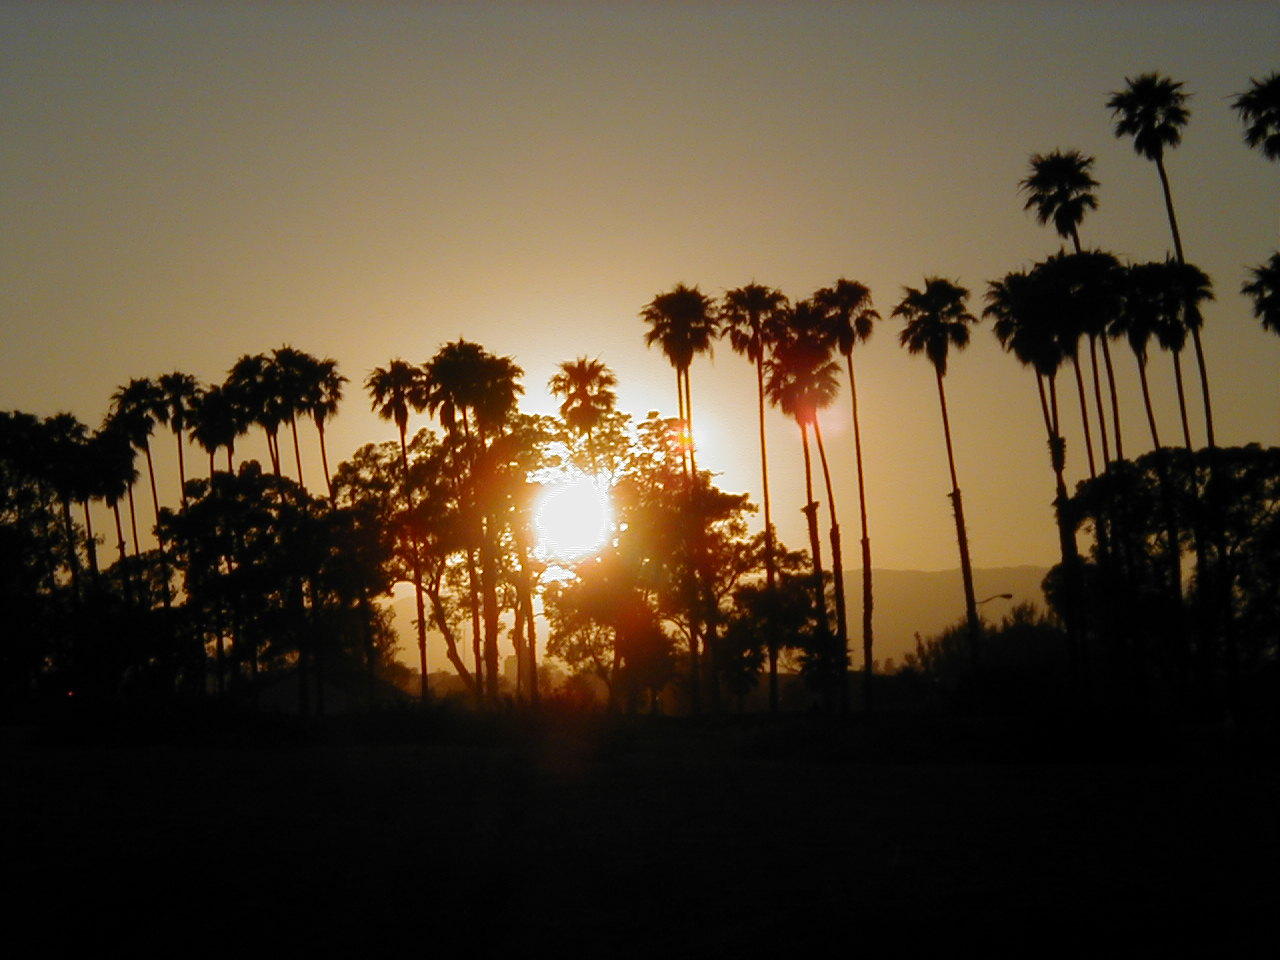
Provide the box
[892,276,979,660]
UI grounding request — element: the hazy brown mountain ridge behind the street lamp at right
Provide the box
[845,566,1048,667]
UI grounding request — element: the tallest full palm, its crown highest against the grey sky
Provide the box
[1107,73,1216,449]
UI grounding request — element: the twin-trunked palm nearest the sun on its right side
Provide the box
[640,283,718,713]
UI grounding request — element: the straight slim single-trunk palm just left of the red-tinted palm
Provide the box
[717,283,787,713]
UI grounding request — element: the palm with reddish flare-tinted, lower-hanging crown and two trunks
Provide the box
[764,300,847,704]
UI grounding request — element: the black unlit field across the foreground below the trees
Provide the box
[0,716,1280,957]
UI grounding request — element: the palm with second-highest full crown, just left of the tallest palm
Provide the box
[1018,150,1119,476]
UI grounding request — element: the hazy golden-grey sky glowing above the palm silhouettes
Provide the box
[0,3,1280,593]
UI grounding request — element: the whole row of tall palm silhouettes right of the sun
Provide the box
[640,73,1280,703]
